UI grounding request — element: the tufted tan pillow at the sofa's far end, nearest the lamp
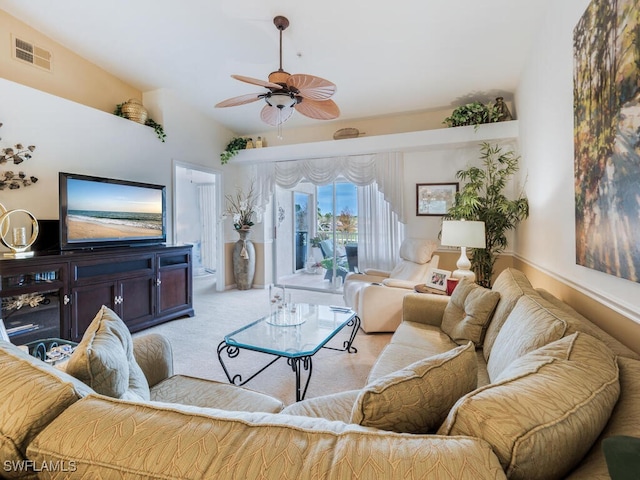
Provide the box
[442,278,500,347]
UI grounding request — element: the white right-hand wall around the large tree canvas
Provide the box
[516,0,640,323]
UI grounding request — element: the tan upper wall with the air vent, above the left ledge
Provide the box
[0,10,142,113]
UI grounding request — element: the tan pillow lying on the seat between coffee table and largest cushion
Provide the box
[351,342,478,433]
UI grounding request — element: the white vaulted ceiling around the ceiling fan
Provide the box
[0,0,551,134]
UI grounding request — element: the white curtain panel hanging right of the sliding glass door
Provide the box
[358,183,405,270]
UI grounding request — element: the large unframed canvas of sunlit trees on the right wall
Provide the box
[573,0,640,282]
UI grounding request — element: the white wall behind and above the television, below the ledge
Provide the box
[0,79,233,249]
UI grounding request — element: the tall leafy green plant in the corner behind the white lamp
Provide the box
[444,143,529,288]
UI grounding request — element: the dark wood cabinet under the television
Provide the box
[0,245,194,345]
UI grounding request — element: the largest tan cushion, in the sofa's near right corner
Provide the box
[438,332,620,480]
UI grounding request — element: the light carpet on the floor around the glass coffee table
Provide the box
[134,275,391,405]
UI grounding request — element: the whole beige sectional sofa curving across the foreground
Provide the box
[0,269,640,479]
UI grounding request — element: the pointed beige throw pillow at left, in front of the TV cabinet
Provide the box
[66,305,149,400]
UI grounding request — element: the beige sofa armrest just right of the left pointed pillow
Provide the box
[133,333,173,387]
